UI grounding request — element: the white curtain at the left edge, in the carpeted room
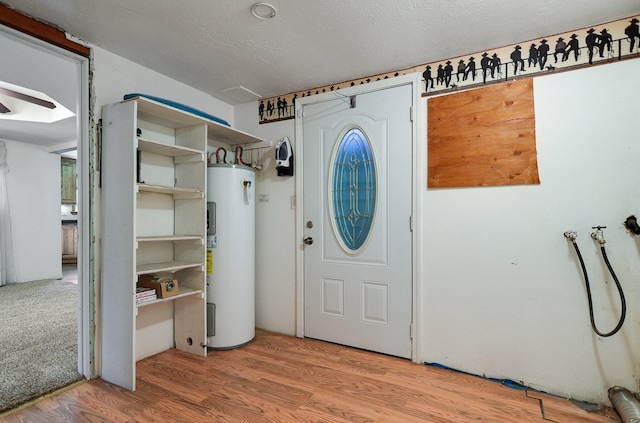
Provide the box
[0,141,16,286]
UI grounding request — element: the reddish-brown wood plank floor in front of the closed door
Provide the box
[0,331,620,423]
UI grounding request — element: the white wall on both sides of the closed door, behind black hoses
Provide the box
[236,60,640,403]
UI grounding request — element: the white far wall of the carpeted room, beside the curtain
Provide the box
[4,140,62,282]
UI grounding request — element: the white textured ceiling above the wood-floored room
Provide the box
[0,0,640,104]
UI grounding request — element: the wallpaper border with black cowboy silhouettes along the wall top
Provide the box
[258,17,640,124]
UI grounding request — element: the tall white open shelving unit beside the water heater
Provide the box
[101,97,261,390]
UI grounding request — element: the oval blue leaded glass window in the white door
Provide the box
[330,128,377,254]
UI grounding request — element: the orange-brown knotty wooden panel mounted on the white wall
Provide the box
[427,79,540,188]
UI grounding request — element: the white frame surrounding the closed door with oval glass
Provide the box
[293,73,423,362]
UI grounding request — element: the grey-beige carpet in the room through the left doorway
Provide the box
[0,280,82,412]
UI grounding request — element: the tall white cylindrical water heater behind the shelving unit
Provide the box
[207,164,255,349]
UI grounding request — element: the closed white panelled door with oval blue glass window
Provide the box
[302,84,413,358]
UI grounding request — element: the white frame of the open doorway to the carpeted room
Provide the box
[0,25,96,379]
